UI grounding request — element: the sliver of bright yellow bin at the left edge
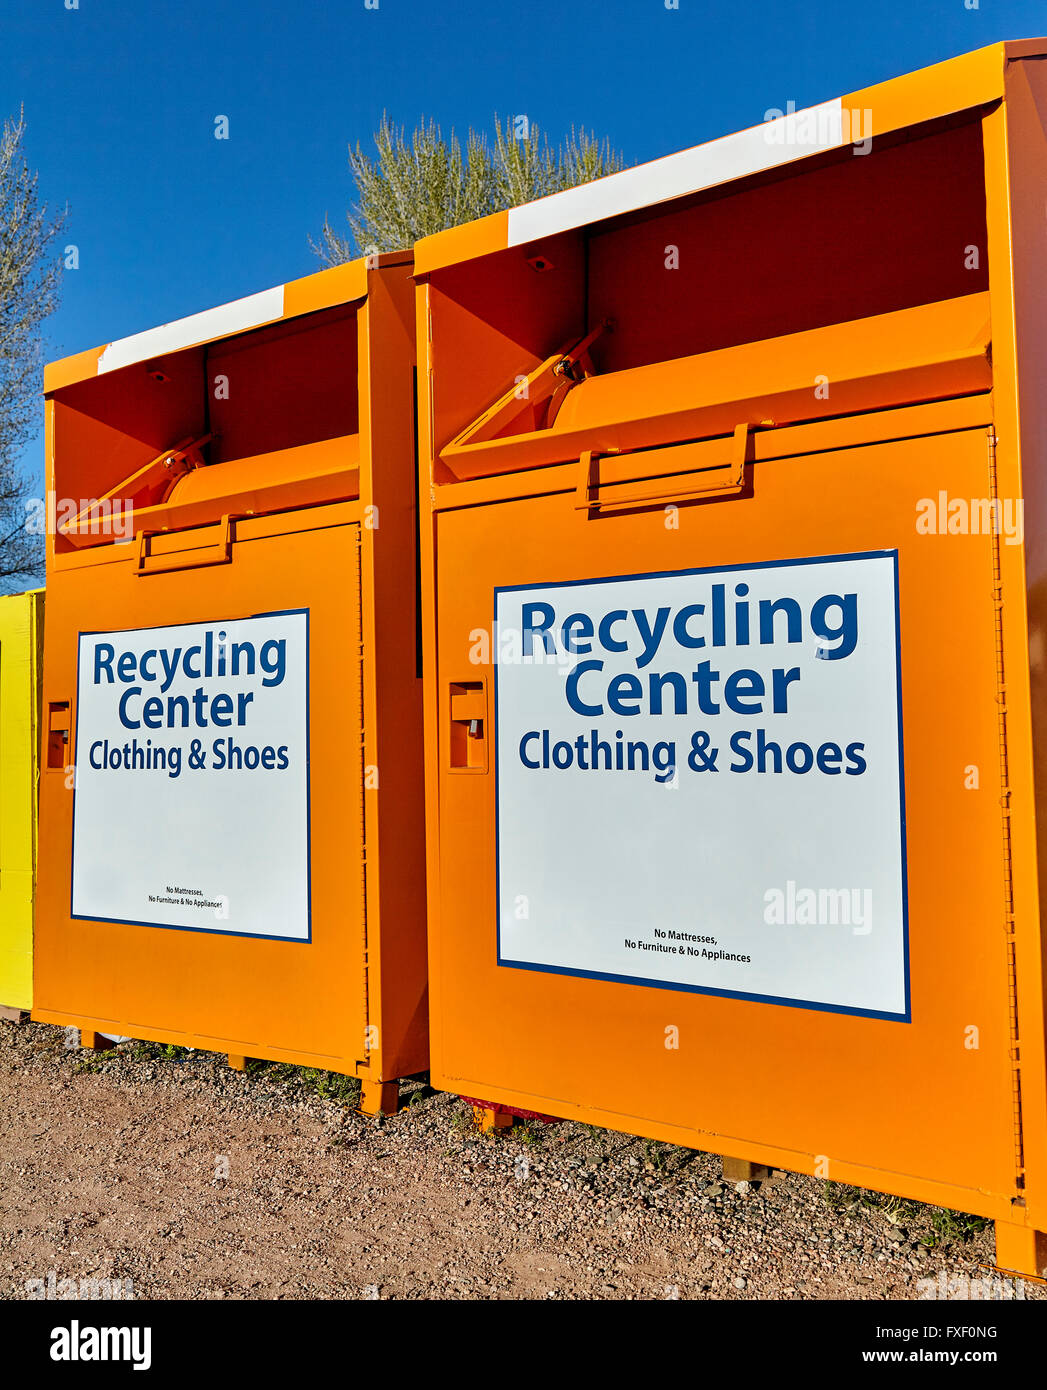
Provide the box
[0,589,43,1017]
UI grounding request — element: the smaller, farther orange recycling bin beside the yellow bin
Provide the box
[33,254,427,1109]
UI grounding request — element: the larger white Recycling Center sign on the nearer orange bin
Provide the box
[495,552,909,1020]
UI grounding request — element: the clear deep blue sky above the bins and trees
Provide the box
[0,0,1047,486]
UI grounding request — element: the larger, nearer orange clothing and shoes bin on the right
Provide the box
[416,40,1047,1273]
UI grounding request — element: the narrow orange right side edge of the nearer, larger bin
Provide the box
[983,58,1047,1230]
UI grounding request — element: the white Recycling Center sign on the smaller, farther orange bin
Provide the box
[72,612,310,941]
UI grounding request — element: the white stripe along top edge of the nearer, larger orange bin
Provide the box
[509,97,848,246]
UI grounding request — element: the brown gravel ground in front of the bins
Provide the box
[0,1022,1047,1300]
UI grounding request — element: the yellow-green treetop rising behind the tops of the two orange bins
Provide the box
[311,117,623,265]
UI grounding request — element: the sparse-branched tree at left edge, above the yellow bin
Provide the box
[0,114,64,589]
